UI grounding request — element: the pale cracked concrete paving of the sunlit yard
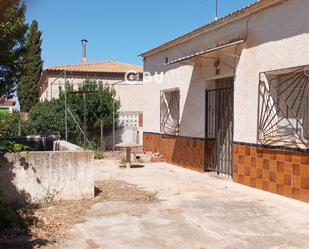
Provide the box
[60,160,309,249]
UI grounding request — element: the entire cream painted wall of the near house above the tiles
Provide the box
[144,0,309,143]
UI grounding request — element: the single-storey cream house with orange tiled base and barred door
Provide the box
[142,0,309,201]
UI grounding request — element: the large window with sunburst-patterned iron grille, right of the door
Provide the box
[258,67,309,148]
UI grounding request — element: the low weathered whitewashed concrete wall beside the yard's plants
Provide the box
[0,151,94,202]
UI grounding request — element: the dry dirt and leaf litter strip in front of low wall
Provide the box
[0,180,158,249]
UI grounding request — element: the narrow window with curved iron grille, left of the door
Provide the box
[160,88,180,135]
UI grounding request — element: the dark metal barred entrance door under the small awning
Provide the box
[205,88,233,175]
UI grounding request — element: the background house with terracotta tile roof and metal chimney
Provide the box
[38,49,143,147]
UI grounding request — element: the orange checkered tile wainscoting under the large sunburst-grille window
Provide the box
[233,143,309,202]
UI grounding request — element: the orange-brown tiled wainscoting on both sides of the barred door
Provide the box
[144,132,309,202]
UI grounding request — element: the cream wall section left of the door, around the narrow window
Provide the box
[144,43,235,137]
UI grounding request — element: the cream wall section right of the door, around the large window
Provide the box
[234,0,309,143]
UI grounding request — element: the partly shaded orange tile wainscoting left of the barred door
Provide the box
[143,132,205,172]
